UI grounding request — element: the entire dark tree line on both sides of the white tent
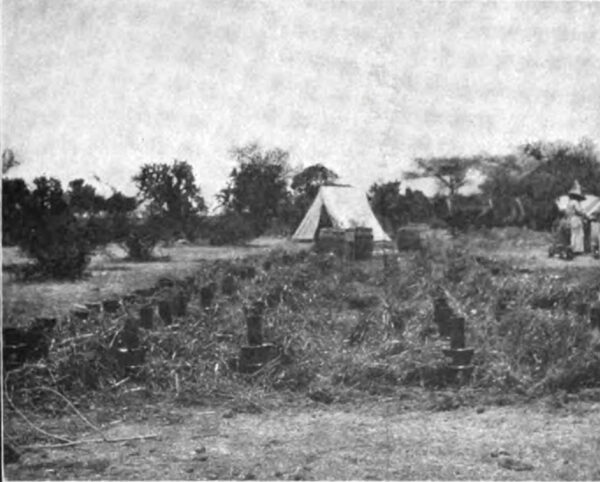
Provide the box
[2,140,600,277]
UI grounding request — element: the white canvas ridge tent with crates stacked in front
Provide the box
[292,186,390,242]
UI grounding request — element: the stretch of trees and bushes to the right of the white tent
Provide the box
[370,139,600,231]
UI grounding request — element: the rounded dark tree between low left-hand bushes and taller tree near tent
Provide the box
[133,160,206,236]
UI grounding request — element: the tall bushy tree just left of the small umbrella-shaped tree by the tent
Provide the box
[218,144,289,234]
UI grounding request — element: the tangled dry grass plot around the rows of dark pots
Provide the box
[4,228,600,412]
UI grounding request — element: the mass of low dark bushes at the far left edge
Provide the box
[2,177,137,278]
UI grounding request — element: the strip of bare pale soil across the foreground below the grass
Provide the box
[5,401,600,480]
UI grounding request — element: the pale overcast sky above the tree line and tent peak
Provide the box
[1,0,600,201]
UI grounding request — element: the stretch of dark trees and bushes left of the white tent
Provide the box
[2,144,337,278]
